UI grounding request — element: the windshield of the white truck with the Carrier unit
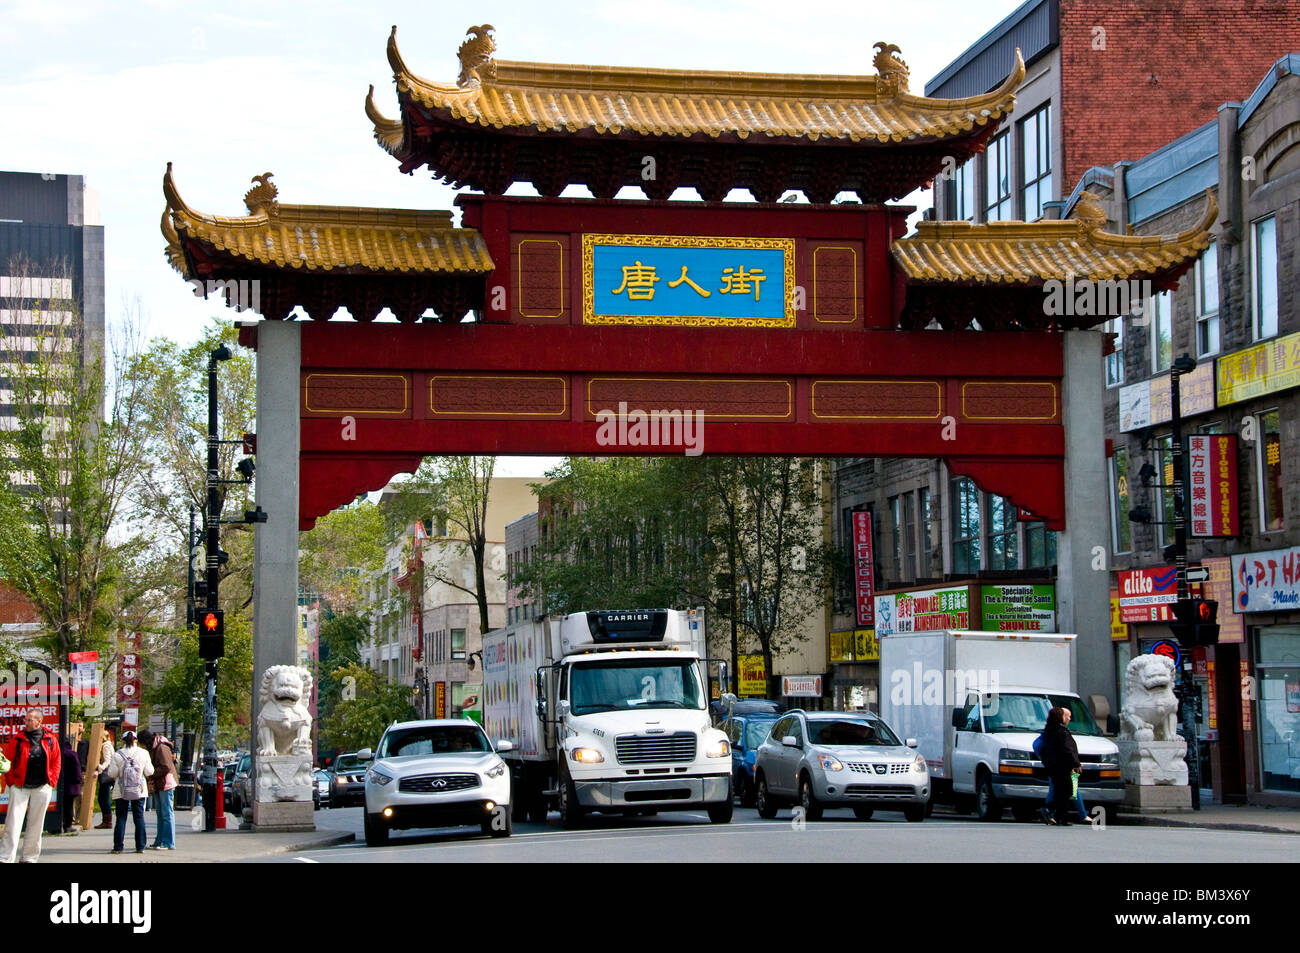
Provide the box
[569,659,705,715]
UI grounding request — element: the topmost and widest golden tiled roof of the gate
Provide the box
[377,25,1024,144]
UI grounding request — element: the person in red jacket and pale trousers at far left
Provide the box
[0,709,62,863]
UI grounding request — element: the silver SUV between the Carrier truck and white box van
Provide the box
[754,709,930,820]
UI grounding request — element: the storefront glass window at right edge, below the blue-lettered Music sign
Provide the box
[1255,625,1300,792]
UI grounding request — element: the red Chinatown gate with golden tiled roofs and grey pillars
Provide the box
[163,26,1217,811]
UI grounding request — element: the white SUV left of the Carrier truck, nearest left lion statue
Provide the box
[361,718,511,846]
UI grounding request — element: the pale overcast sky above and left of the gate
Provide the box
[0,0,1019,475]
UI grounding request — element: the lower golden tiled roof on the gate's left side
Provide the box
[163,163,493,278]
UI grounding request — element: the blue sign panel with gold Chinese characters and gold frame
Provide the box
[582,234,794,328]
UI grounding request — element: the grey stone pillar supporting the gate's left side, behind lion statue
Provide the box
[250,321,312,827]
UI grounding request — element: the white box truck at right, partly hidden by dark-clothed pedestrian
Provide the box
[880,629,1125,820]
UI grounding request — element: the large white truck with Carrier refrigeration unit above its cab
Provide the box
[484,608,732,827]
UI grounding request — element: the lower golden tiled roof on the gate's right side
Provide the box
[892,191,1218,285]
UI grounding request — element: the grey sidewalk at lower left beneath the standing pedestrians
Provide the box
[26,811,355,863]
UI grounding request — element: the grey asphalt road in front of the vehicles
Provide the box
[256,807,1300,863]
